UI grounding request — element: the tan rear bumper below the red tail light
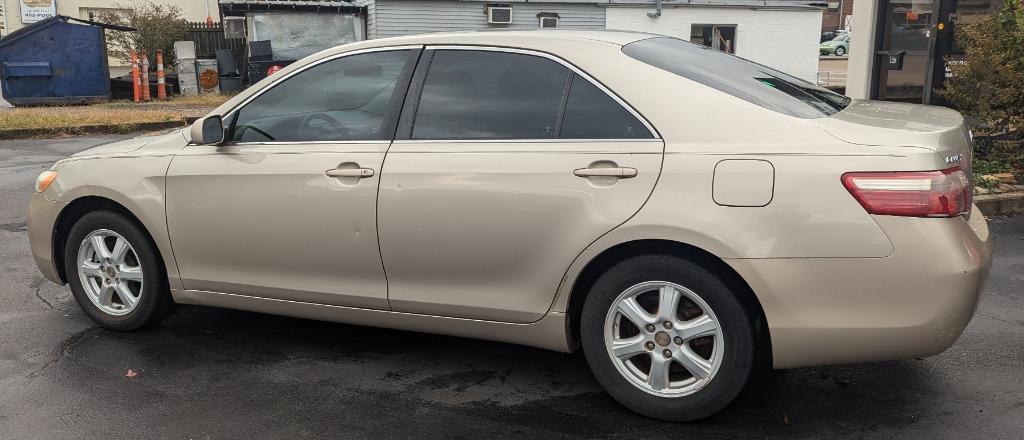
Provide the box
[727,204,992,368]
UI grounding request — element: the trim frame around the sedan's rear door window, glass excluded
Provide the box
[394,44,663,143]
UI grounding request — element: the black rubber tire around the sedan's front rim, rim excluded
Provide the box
[65,211,177,332]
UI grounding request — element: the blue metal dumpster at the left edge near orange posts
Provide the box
[0,15,134,105]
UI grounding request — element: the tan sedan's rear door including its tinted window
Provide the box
[378,47,664,322]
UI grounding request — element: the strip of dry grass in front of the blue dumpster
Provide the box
[0,105,182,133]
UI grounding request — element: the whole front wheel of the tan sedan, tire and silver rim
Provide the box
[65,211,174,331]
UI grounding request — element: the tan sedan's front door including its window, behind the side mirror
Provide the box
[167,49,419,309]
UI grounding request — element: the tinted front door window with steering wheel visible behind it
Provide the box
[231,50,410,142]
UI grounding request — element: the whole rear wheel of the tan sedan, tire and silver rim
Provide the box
[581,255,754,422]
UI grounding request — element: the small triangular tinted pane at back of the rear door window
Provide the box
[559,76,652,139]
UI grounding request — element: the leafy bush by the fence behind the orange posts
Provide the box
[97,1,188,67]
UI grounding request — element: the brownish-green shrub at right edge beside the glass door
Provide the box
[939,0,1024,139]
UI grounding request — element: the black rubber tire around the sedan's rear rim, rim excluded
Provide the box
[580,255,755,422]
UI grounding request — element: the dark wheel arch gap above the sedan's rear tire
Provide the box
[565,238,772,366]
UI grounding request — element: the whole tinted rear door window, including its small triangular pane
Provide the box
[412,50,653,139]
